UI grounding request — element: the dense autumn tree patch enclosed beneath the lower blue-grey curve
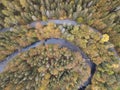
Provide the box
[0,45,90,90]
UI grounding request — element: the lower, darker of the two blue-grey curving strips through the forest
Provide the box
[0,38,95,88]
